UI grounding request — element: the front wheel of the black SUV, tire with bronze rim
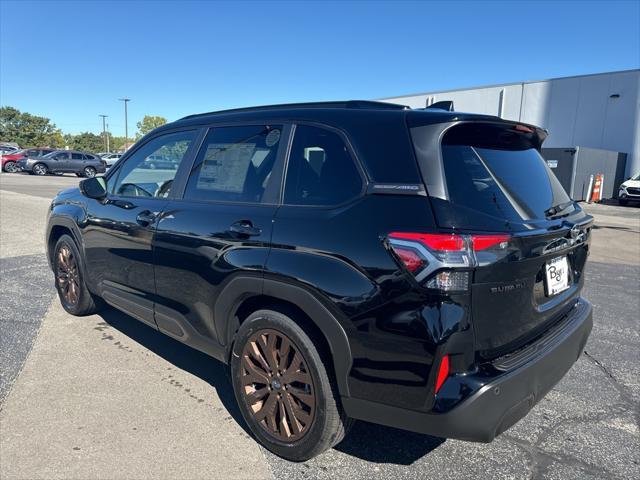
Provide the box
[53,235,103,316]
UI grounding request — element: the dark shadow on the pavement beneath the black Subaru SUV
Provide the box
[99,307,445,465]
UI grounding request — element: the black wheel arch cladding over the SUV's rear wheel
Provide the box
[214,277,352,396]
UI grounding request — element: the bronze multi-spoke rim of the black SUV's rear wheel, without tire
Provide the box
[241,330,316,443]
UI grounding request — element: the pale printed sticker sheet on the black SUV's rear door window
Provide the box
[197,143,256,193]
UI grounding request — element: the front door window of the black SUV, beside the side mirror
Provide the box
[108,130,197,198]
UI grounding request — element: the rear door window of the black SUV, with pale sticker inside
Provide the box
[184,125,282,202]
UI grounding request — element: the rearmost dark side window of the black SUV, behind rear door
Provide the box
[284,125,362,205]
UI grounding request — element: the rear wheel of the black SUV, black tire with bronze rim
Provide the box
[231,310,352,462]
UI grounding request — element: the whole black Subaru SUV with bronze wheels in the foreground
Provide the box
[46,101,592,460]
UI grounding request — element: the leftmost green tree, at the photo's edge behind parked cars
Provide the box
[0,107,62,147]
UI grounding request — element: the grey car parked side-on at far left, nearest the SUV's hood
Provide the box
[17,150,107,177]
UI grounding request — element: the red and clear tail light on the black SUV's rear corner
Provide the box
[387,232,511,292]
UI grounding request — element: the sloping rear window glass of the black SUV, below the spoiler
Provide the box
[442,145,570,221]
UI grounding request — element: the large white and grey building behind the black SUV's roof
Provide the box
[382,70,640,176]
